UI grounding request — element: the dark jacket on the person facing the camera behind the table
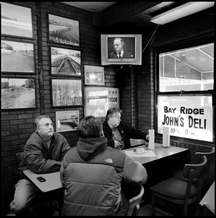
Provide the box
[103,120,147,149]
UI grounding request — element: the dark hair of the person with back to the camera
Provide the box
[78,116,102,138]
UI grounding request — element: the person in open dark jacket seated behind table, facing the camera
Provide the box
[103,108,149,149]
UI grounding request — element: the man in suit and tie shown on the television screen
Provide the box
[109,37,134,58]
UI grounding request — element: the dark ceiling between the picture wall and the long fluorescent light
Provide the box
[62,0,213,28]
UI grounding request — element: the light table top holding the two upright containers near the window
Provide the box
[124,143,188,164]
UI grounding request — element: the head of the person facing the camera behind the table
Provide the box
[106,107,121,128]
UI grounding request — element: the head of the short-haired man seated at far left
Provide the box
[35,115,54,138]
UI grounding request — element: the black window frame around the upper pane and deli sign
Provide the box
[153,36,216,145]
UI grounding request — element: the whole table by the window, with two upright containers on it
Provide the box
[124,143,190,202]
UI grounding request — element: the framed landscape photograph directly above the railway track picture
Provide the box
[48,14,79,46]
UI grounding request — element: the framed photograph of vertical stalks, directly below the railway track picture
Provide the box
[52,79,82,107]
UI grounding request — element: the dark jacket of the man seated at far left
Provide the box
[24,132,70,173]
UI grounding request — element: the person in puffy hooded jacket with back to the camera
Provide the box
[60,116,147,216]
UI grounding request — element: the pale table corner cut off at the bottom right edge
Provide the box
[200,182,215,213]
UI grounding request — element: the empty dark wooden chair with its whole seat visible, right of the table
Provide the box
[150,154,207,216]
